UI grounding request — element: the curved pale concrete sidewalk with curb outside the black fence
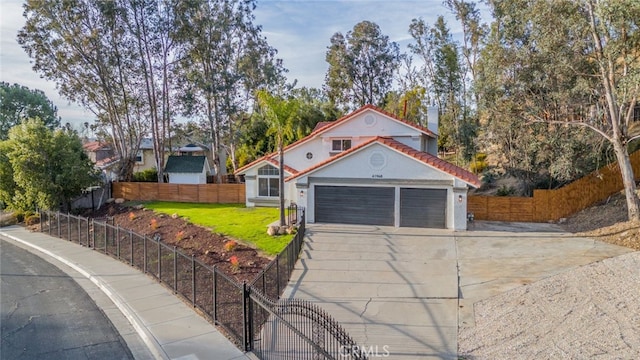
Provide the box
[0,226,255,360]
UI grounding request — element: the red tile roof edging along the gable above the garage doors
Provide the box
[286,136,481,188]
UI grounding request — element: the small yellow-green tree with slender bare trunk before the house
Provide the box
[257,90,299,226]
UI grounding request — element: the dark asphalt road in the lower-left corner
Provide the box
[0,240,133,360]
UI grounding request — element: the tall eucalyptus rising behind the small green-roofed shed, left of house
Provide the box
[176,0,284,179]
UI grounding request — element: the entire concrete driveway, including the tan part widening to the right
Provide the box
[285,222,631,360]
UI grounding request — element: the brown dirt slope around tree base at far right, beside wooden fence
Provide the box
[561,192,640,250]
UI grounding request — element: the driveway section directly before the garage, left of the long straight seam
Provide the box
[285,224,458,359]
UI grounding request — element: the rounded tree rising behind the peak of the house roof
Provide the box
[324,21,402,110]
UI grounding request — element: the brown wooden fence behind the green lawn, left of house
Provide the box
[113,182,245,204]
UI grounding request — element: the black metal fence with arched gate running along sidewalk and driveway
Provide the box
[40,207,366,359]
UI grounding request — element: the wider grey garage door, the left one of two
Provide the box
[314,186,395,226]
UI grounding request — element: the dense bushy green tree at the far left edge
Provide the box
[0,119,99,210]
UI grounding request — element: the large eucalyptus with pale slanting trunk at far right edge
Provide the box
[481,0,640,221]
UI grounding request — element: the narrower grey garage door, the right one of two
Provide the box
[400,188,447,228]
